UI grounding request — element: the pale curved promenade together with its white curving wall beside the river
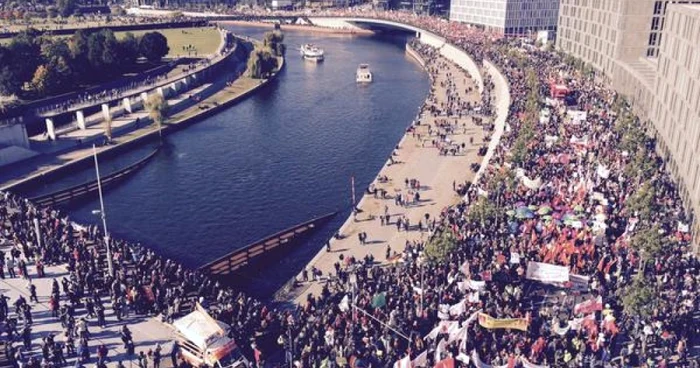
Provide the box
[276,33,510,304]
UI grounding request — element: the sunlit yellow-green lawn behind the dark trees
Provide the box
[116,27,221,57]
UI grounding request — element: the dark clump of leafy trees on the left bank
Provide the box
[0,29,169,98]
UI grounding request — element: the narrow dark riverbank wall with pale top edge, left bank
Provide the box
[0,37,286,192]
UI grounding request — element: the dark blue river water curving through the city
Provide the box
[28,27,429,296]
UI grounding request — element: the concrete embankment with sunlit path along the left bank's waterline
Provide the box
[0,38,285,192]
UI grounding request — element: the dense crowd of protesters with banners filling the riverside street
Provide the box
[0,13,700,367]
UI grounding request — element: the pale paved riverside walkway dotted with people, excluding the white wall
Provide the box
[278,51,486,303]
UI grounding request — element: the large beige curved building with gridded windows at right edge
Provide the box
[557,0,700,240]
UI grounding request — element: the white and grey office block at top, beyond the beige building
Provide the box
[450,0,559,35]
